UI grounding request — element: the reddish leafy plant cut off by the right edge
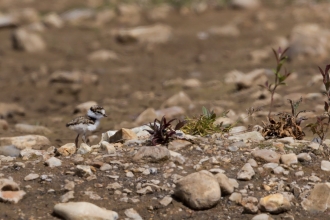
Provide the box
[306,65,330,144]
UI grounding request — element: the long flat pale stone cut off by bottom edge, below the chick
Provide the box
[54,202,118,220]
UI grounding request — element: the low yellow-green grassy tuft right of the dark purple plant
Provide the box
[182,107,231,136]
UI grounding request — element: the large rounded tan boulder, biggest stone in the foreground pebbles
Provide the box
[174,170,221,209]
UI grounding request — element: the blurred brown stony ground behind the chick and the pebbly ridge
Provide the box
[0,0,330,145]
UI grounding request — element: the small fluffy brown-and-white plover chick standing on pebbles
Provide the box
[66,105,107,147]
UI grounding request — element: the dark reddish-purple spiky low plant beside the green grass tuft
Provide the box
[146,116,185,145]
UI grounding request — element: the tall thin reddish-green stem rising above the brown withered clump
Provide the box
[260,48,291,118]
